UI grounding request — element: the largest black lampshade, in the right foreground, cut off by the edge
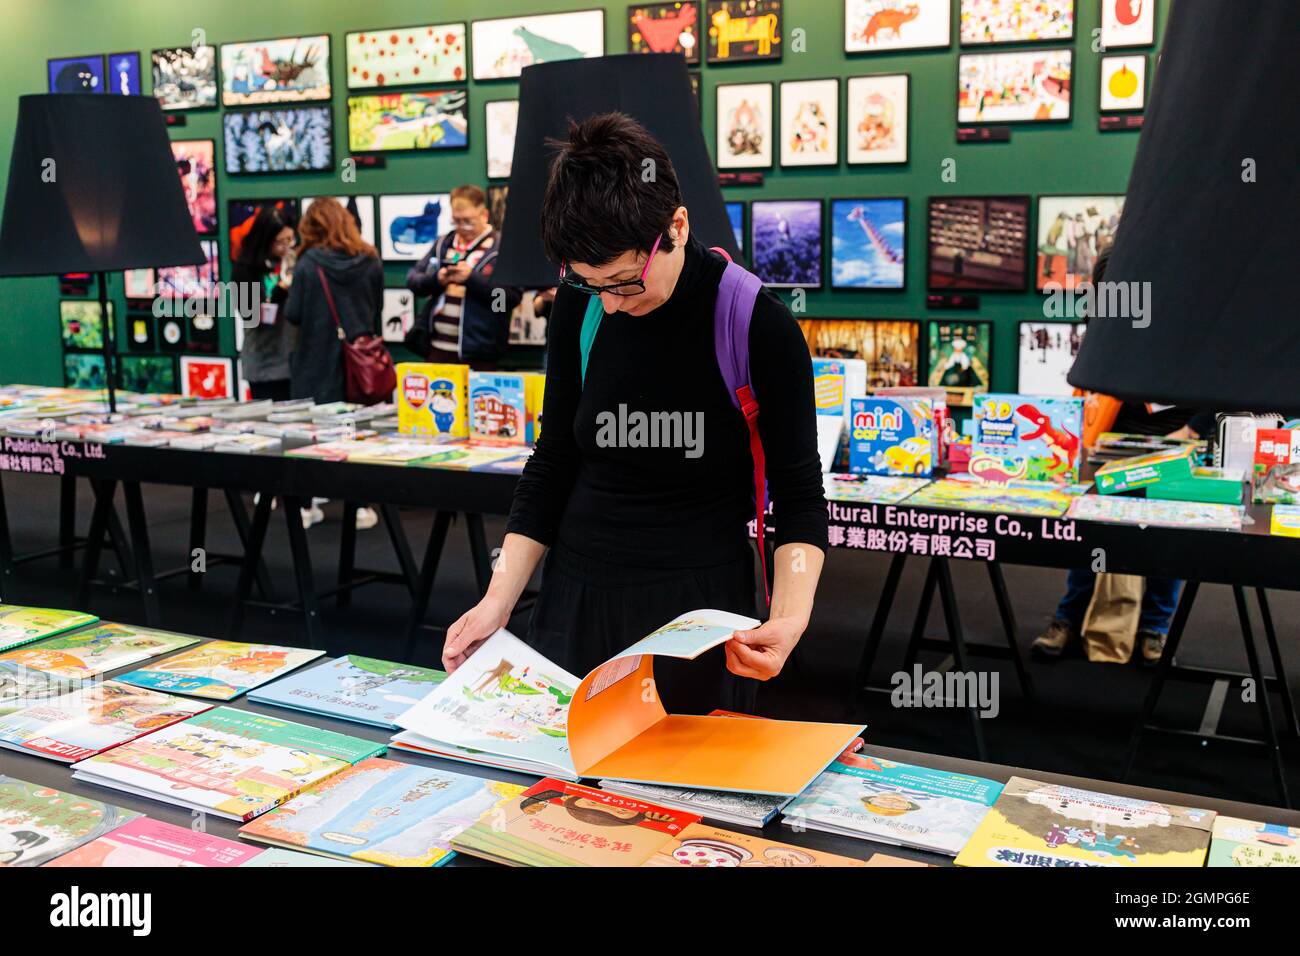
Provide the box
[1070,0,1300,414]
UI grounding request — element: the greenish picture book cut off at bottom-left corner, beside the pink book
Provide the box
[0,774,140,866]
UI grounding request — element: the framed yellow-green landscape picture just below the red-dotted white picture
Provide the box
[347,87,469,152]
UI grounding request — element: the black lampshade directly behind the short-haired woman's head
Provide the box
[493,53,740,289]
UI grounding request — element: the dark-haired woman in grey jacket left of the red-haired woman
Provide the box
[230,206,295,402]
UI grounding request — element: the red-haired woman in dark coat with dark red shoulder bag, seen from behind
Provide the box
[285,198,397,528]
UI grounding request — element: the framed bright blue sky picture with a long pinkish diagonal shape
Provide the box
[831,198,907,289]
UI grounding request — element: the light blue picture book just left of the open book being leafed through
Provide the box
[248,654,447,730]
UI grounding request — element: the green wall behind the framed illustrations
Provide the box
[0,0,1170,389]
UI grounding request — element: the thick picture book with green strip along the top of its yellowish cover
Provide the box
[73,708,385,822]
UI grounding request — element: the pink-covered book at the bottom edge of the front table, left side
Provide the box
[46,817,263,868]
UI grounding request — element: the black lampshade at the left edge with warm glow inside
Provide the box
[0,94,207,276]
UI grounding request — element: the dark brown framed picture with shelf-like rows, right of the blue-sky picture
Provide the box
[926,196,1030,293]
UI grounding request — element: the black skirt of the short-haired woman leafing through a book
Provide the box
[528,545,758,714]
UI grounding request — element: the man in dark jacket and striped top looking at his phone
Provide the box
[407,186,520,369]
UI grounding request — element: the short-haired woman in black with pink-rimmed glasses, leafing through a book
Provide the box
[443,113,827,713]
